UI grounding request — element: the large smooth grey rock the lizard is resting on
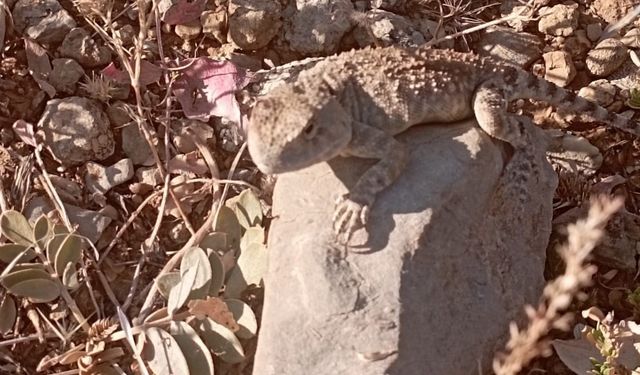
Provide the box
[254,121,557,375]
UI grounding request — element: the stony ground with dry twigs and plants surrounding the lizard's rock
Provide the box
[0,0,640,374]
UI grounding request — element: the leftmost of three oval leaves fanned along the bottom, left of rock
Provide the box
[139,327,189,375]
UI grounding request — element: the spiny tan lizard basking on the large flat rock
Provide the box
[247,46,640,242]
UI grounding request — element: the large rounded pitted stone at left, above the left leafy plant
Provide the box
[38,96,115,166]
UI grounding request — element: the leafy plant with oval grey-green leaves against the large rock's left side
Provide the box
[139,190,266,374]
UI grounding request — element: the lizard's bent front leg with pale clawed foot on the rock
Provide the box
[333,121,407,243]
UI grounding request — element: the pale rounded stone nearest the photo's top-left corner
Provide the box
[12,0,76,44]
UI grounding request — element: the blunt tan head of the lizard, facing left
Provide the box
[247,85,352,173]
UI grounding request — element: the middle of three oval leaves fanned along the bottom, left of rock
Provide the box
[169,321,214,375]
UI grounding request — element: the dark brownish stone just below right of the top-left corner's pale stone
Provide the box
[60,27,111,68]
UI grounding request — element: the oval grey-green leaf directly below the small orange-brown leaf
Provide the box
[197,318,245,364]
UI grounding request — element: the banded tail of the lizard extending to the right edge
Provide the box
[505,68,640,136]
